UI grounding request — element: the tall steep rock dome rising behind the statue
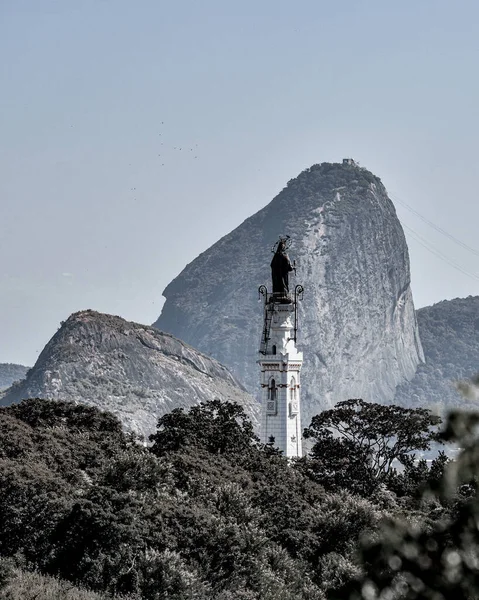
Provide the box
[155,157,423,424]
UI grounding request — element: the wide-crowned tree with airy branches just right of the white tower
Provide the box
[304,399,441,495]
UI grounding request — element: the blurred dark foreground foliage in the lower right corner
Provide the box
[340,390,479,600]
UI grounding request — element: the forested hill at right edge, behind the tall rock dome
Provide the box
[395,296,479,410]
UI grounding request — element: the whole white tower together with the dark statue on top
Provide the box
[258,237,303,458]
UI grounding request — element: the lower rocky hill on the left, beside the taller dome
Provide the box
[0,311,258,436]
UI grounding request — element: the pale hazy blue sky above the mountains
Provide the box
[0,0,479,365]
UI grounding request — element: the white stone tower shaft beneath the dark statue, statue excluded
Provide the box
[258,303,303,458]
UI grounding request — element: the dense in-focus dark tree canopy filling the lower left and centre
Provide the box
[0,399,381,600]
